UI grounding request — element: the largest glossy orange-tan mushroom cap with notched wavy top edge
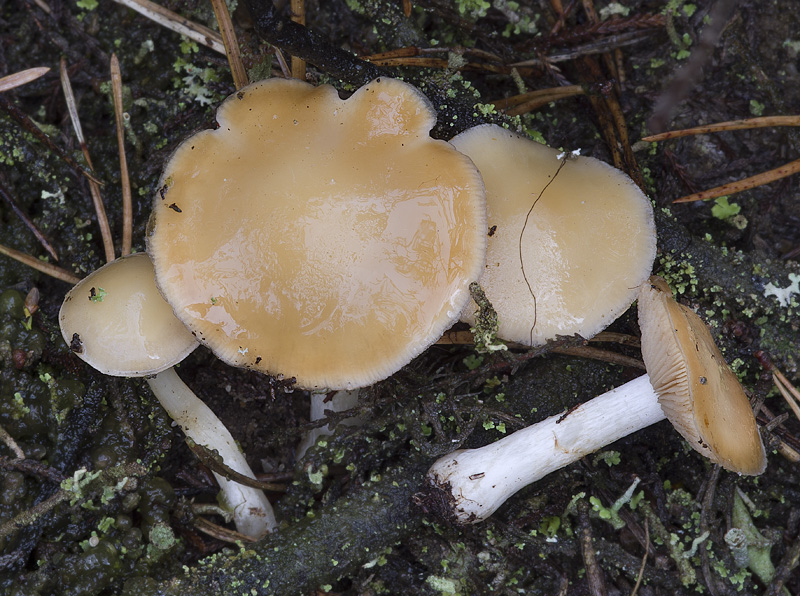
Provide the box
[148,79,485,389]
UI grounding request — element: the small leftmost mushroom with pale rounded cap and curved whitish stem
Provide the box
[59,253,277,538]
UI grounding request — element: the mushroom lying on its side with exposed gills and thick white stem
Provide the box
[428,277,766,523]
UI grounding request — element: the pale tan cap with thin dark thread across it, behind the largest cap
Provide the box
[451,125,656,345]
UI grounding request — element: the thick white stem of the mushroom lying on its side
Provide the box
[428,375,664,523]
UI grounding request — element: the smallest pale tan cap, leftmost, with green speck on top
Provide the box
[58,253,198,377]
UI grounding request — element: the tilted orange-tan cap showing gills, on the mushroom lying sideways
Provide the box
[639,276,767,475]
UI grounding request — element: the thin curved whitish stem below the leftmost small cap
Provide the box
[147,368,277,539]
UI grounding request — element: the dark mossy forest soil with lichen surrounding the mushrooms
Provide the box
[0,0,800,596]
